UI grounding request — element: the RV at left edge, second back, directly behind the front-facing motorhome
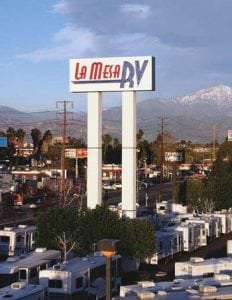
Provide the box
[0,248,61,287]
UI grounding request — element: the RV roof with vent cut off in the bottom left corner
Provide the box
[0,282,46,300]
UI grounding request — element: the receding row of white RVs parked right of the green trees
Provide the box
[147,201,232,264]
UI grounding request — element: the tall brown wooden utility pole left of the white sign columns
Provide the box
[56,100,73,202]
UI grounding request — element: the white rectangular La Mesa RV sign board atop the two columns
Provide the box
[69,56,155,92]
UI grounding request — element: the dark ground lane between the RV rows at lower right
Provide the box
[122,232,232,285]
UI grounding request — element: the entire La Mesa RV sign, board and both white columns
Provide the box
[69,56,155,218]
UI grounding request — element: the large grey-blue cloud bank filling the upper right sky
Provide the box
[14,0,232,97]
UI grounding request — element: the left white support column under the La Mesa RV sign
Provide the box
[87,92,102,209]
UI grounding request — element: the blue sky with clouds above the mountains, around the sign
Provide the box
[0,0,232,111]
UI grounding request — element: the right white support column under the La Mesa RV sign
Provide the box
[122,91,137,218]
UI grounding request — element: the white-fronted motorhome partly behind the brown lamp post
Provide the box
[39,252,121,297]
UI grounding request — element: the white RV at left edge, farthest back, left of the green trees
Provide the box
[0,225,36,256]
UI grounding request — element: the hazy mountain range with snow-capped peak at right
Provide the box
[0,85,232,143]
